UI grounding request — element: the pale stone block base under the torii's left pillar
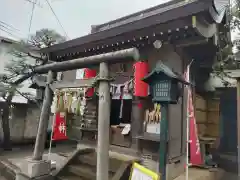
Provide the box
[21,159,51,178]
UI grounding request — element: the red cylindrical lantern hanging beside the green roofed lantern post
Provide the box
[134,61,149,97]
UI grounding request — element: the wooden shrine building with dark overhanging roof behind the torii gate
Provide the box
[42,0,229,179]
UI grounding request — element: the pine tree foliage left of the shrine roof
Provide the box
[0,29,66,100]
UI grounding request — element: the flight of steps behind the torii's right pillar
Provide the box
[56,149,134,180]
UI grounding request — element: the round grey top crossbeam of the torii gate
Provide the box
[33,48,140,74]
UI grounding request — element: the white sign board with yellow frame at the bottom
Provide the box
[129,163,160,180]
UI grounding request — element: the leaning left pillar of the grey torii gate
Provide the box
[32,71,54,160]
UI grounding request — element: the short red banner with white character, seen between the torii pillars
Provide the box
[52,112,68,141]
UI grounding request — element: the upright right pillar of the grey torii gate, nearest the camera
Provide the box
[97,63,110,180]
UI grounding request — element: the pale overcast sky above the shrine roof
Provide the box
[0,0,172,39]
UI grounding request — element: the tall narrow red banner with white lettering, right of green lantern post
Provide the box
[185,67,203,165]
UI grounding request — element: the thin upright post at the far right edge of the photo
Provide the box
[237,78,240,179]
